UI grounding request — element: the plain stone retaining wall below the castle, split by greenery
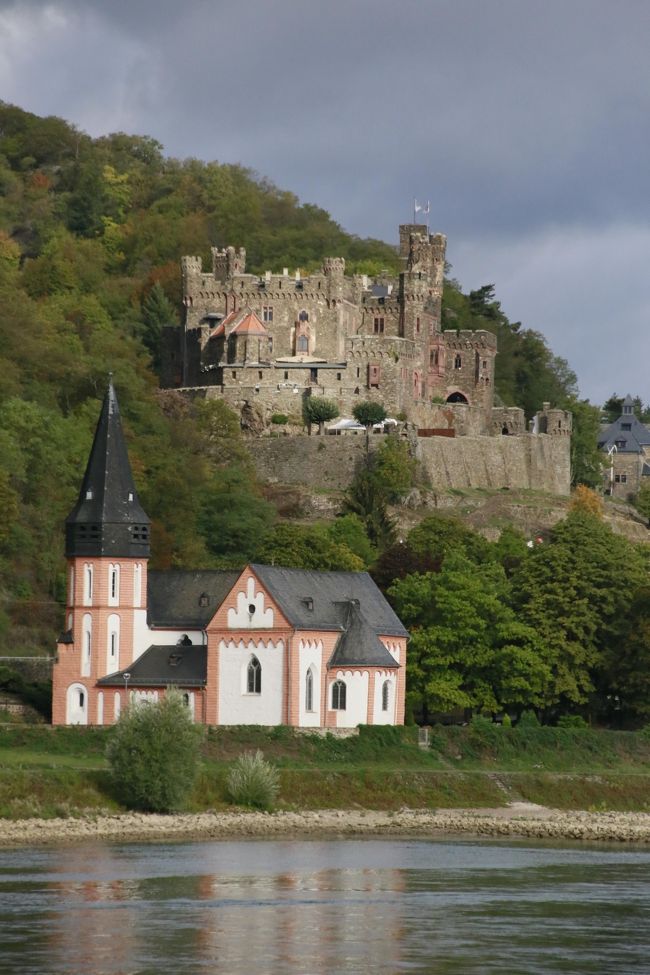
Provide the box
[251,433,571,495]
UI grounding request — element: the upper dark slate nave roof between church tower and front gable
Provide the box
[147,569,241,629]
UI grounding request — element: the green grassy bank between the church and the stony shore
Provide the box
[0,722,650,819]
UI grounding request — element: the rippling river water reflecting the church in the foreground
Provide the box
[0,838,650,975]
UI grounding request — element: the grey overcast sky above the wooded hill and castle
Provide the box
[0,0,650,402]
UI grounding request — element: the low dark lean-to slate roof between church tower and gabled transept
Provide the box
[97,644,208,687]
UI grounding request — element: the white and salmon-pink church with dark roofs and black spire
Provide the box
[52,382,408,729]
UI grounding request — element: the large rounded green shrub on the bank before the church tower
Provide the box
[106,691,203,813]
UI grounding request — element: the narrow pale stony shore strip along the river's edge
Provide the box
[0,802,650,847]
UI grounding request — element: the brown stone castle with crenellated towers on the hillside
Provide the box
[162,224,571,493]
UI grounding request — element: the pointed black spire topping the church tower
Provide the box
[65,380,150,558]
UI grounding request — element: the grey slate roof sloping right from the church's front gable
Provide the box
[251,564,408,636]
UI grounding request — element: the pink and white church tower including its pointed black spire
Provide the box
[52,382,150,724]
